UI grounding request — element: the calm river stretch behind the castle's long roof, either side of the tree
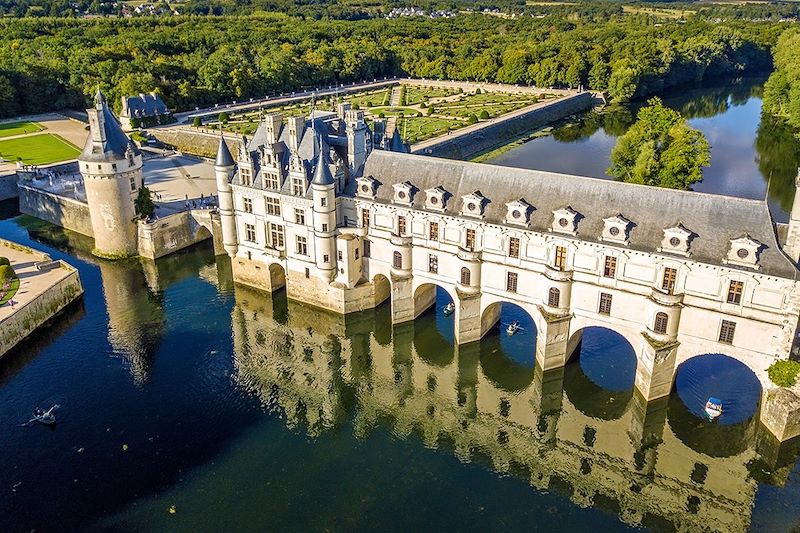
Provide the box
[489,79,800,222]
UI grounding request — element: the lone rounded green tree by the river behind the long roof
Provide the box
[608,98,711,189]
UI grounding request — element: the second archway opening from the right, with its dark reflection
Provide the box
[564,326,636,420]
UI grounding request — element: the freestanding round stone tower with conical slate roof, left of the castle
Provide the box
[78,90,142,259]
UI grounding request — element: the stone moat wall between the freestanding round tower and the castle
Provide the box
[138,211,211,259]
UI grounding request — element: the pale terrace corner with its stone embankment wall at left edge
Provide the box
[0,239,83,357]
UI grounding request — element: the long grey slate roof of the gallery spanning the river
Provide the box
[356,150,797,279]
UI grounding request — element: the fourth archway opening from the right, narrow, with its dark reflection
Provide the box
[414,283,457,366]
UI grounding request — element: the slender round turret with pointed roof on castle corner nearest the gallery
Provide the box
[311,141,336,282]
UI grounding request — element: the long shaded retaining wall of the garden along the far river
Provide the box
[412,92,592,159]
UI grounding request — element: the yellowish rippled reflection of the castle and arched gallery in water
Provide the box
[232,285,795,531]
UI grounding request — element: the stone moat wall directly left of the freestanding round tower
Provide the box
[19,183,94,237]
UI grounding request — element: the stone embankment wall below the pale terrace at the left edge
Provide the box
[0,261,83,357]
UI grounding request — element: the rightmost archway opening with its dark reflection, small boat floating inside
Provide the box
[668,353,761,457]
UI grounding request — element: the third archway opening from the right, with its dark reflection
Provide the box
[480,302,537,392]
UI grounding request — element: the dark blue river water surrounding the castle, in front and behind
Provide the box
[0,79,800,531]
